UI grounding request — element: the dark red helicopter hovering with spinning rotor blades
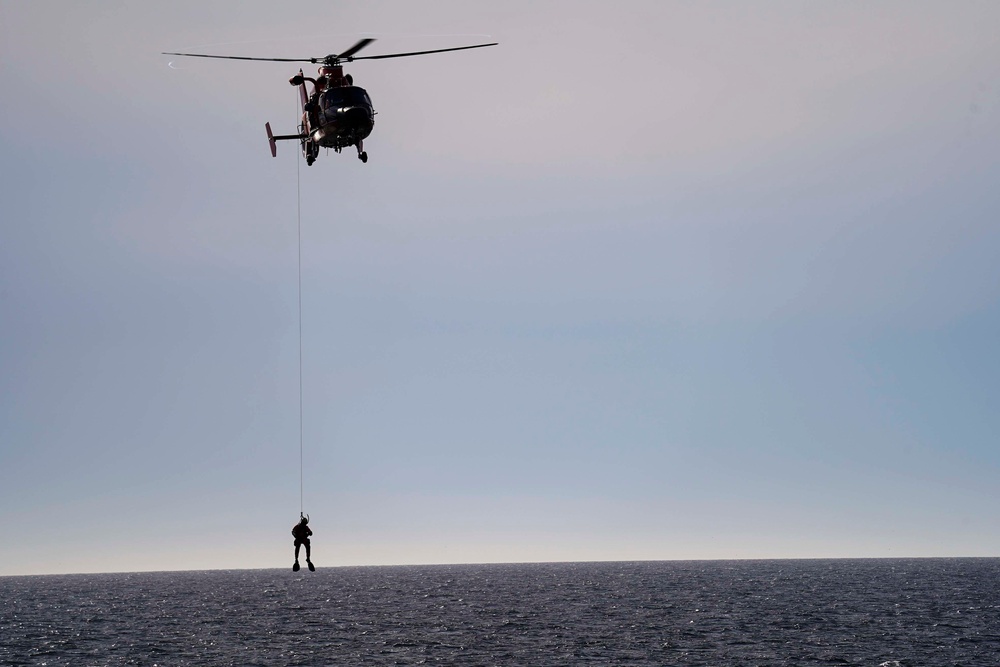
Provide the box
[162,37,497,166]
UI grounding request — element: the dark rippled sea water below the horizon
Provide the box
[0,559,1000,667]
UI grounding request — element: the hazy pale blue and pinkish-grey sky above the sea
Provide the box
[0,0,1000,575]
